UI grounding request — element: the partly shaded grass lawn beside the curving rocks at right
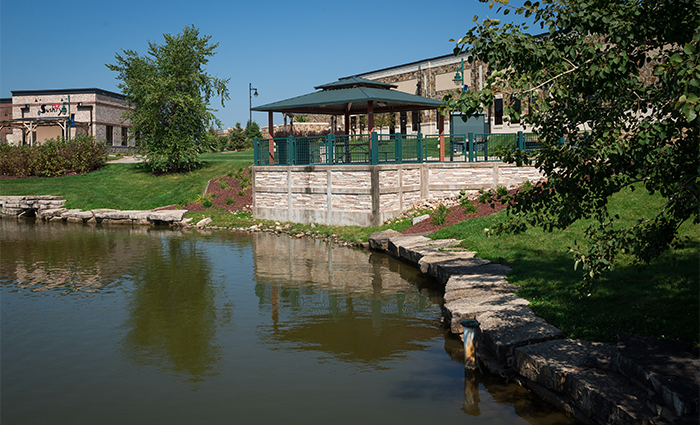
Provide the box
[432,190,700,347]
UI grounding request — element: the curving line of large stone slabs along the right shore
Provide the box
[369,230,700,425]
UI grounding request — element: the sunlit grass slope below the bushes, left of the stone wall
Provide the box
[0,151,253,210]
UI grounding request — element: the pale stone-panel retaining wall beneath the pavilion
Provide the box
[253,162,542,226]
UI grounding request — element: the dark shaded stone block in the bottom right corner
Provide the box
[616,332,700,416]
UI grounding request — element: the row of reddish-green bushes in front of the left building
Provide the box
[0,135,107,177]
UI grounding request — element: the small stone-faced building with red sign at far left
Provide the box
[0,88,135,146]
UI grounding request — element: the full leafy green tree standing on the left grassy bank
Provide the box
[106,26,229,172]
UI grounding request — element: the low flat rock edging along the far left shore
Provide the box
[0,196,187,225]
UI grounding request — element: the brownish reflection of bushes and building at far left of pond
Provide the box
[0,220,161,293]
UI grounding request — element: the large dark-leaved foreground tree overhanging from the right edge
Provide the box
[444,0,700,283]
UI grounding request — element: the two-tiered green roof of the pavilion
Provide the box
[252,77,442,115]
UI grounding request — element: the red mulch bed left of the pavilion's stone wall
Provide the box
[159,169,253,212]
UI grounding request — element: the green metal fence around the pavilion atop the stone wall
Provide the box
[253,132,538,165]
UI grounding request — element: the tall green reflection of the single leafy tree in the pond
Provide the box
[122,237,220,382]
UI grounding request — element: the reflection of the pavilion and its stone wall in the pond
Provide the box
[254,234,441,363]
